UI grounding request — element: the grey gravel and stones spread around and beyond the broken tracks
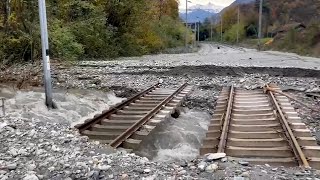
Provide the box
[0,44,320,180]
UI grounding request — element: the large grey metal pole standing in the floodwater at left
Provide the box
[38,0,55,109]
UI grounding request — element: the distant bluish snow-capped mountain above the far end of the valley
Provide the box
[180,3,223,22]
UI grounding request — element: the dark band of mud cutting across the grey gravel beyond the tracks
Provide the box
[100,65,320,78]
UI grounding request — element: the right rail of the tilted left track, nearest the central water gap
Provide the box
[109,83,187,148]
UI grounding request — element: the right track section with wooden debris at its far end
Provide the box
[200,85,320,169]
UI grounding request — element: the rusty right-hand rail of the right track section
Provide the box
[266,85,310,168]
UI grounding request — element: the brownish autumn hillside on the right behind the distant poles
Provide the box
[207,0,320,56]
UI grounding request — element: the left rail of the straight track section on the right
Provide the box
[217,85,234,153]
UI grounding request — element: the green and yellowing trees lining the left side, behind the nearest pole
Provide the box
[0,0,184,63]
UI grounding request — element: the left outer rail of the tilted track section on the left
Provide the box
[76,83,160,133]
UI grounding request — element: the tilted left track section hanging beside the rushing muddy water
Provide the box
[77,83,192,151]
